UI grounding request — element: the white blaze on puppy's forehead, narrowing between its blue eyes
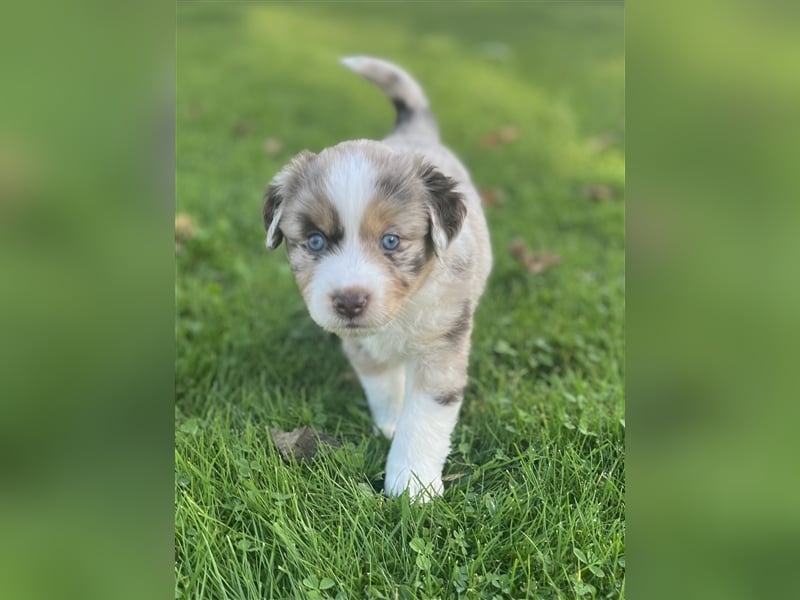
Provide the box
[326,152,375,240]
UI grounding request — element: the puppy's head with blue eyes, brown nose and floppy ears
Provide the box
[263,141,467,336]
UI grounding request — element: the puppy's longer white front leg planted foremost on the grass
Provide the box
[385,355,467,502]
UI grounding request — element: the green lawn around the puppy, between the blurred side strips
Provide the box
[175,3,625,599]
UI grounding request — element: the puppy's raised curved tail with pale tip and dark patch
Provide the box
[341,56,439,139]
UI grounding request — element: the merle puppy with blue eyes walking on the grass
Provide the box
[263,57,492,501]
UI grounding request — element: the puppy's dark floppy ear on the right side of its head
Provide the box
[420,164,467,256]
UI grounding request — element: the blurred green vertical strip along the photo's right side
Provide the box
[626,1,800,598]
